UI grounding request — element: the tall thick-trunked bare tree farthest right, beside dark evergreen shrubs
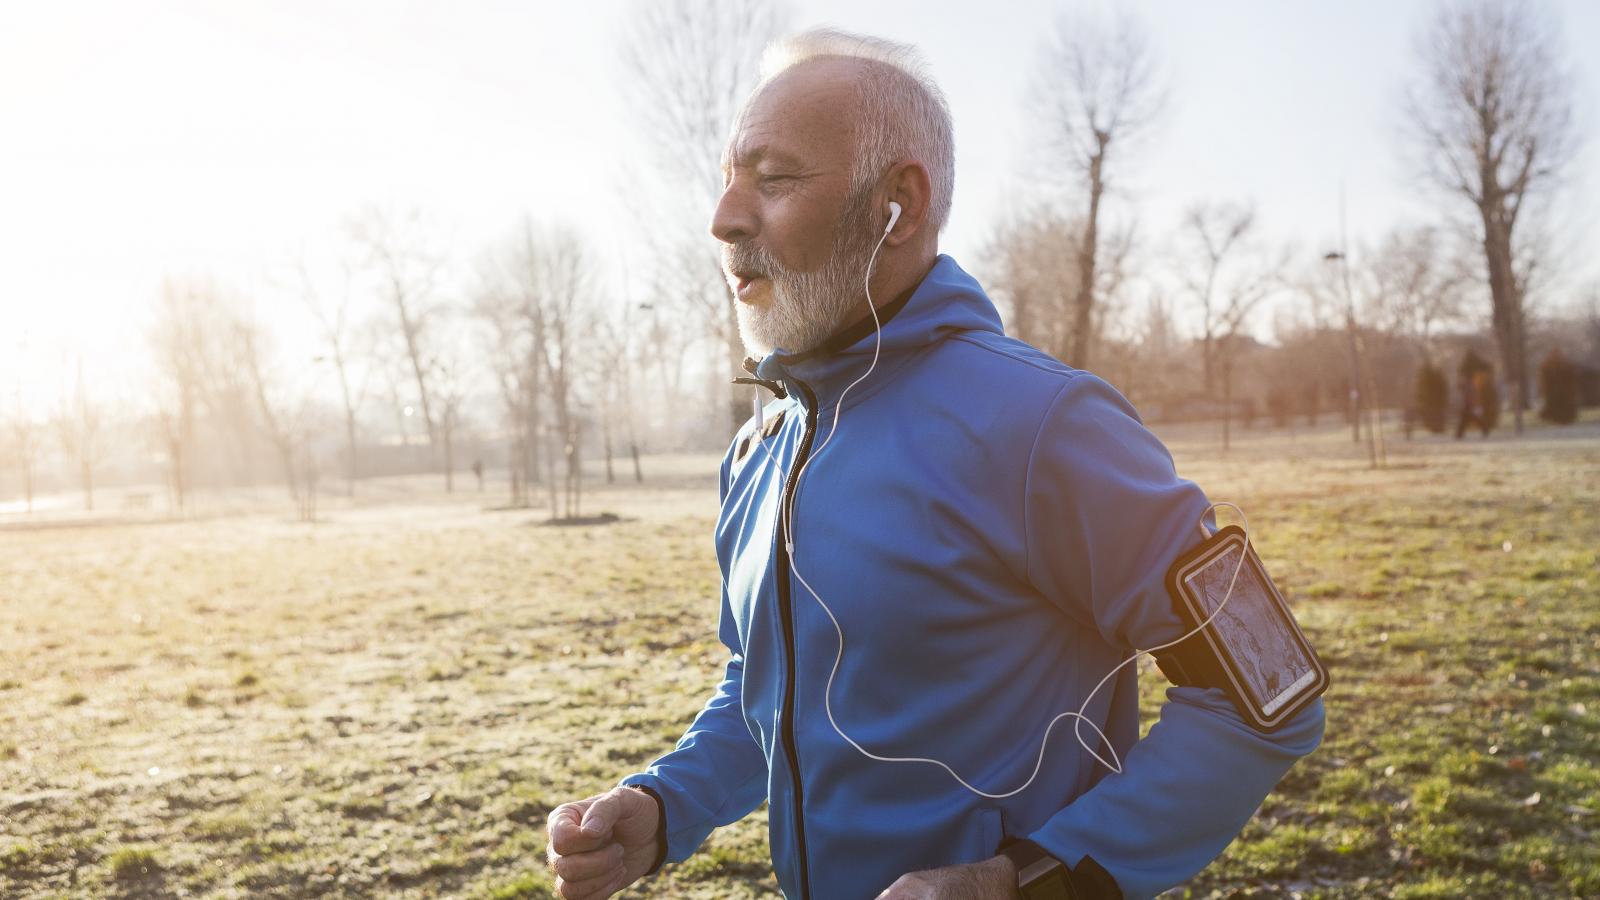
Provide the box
[1406,0,1576,434]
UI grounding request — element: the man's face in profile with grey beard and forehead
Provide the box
[710,59,874,356]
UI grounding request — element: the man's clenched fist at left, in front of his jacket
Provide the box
[546,788,661,900]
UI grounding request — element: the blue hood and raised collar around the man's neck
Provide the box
[755,253,1002,407]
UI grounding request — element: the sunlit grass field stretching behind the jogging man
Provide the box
[0,421,1600,898]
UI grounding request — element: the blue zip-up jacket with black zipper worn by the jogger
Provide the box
[622,256,1323,900]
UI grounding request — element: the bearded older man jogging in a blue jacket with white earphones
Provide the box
[549,30,1323,900]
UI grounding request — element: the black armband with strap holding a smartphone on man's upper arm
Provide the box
[1155,525,1328,732]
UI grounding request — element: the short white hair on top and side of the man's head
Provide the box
[757,29,955,232]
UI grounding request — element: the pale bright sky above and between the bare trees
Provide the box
[0,0,1600,412]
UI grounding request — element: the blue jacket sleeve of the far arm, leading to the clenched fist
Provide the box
[621,445,766,863]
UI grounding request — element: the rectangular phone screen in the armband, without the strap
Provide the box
[1184,544,1317,716]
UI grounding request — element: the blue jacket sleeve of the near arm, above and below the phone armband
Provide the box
[1024,373,1323,897]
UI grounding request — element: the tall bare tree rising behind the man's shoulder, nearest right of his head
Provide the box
[1035,13,1165,368]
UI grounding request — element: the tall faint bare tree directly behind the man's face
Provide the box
[621,0,787,428]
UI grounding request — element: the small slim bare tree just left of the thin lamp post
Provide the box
[1182,203,1283,450]
